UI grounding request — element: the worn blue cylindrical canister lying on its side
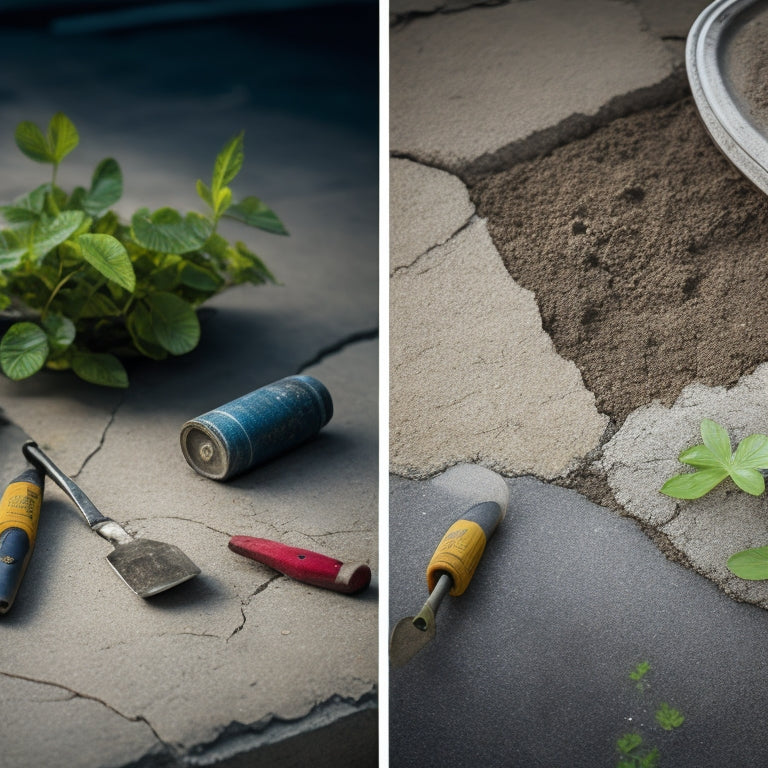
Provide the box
[181,376,333,480]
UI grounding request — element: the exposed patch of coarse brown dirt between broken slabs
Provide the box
[471,99,768,424]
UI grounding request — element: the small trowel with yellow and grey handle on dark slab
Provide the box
[389,501,506,667]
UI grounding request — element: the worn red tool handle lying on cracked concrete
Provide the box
[229,536,371,594]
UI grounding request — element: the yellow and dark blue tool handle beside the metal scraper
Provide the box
[0,467,45,613]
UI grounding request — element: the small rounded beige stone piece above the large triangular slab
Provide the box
[389,159,475,272]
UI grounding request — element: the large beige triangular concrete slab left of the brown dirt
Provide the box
[390,214,608,478]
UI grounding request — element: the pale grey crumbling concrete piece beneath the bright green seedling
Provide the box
[598,364,768,608]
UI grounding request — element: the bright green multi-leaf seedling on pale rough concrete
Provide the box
[661,419,768,499]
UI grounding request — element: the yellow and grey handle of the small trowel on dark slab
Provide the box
[427,501,504,596]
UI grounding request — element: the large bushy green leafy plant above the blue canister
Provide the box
[0,113,287,387]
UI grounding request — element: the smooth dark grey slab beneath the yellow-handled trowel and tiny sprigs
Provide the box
[389,478,768,768]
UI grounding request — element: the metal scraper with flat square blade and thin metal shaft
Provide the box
[22,440,200,597]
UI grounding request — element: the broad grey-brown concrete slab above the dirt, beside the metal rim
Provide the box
[390,0,677,169]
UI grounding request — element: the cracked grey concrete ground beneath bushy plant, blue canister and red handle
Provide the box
[0,6,378,768]
